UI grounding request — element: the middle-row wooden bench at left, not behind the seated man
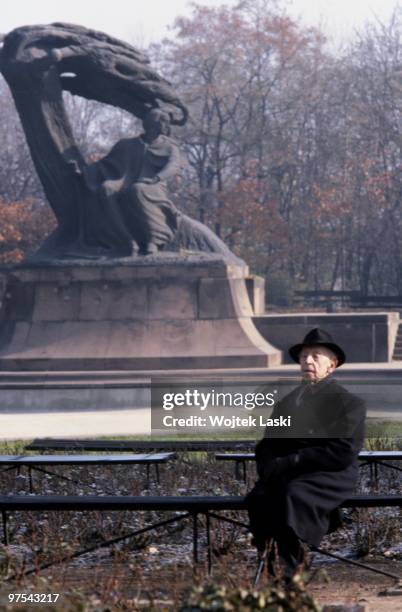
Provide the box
[0,453,176,493]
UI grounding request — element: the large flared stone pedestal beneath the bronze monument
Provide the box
[0,253,281,371]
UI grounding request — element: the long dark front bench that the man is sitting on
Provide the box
[0,495,402,580]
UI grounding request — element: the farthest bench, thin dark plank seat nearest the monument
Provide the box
[25,438,255,452]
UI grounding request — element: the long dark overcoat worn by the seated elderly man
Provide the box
[250,376,366,546]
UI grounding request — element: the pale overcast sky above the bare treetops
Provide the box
[0,0,398,47]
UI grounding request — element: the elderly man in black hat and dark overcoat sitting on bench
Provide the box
[247,328,365,581]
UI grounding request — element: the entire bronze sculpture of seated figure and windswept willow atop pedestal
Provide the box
[0,23,236,259]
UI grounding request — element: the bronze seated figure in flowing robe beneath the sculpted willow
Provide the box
[85,109,181,255]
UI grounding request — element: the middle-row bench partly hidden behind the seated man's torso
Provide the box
[215,451,402,482]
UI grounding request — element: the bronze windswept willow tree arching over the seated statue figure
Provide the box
[0,23,239,258]
